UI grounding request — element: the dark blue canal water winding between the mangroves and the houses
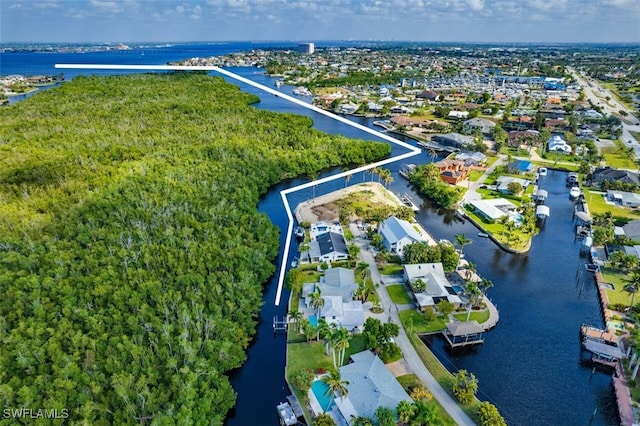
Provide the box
[228,69,618,426]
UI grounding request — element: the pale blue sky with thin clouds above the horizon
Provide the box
[0,0,640,42]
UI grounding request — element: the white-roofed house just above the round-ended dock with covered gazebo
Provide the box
[402,263,462,311]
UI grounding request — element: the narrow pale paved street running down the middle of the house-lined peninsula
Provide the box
[351,226,475,426]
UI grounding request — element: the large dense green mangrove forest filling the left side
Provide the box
[0,73,390,424]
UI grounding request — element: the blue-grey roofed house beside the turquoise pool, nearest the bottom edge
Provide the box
[334,350,413,424]
